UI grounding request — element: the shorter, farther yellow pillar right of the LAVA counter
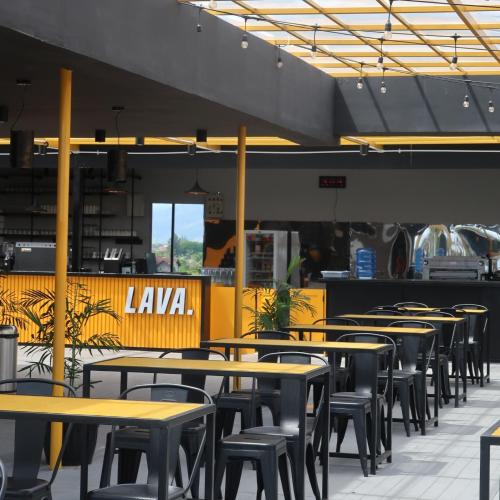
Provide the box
[234,125,247,364]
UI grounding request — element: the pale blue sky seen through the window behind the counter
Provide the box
[152,203,204,244]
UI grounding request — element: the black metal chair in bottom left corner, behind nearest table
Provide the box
[0,378,76,500]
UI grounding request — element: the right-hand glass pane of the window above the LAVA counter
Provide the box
[173,204,204,274]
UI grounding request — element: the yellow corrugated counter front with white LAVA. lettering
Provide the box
[4,272,210,350]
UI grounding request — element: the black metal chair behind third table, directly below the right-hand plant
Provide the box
[231,330,295,425]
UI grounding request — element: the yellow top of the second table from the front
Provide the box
[92,356,318,375]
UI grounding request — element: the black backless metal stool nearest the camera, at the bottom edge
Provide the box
[215,434,291,500]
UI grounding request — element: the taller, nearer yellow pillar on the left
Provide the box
[50,68,72,468]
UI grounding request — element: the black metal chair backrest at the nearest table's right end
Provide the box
[118,384,214,493]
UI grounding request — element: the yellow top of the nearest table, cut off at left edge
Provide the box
[0,394,204,421]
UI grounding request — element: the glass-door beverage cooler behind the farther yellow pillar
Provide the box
[245,231,300,288]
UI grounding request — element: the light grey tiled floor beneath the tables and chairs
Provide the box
[0,352,500,500]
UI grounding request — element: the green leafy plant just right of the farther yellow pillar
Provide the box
[244,257,316,331]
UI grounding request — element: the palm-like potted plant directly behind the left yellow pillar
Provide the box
[21,282,122,390]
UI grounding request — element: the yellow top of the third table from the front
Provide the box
[207,337,387,350]
